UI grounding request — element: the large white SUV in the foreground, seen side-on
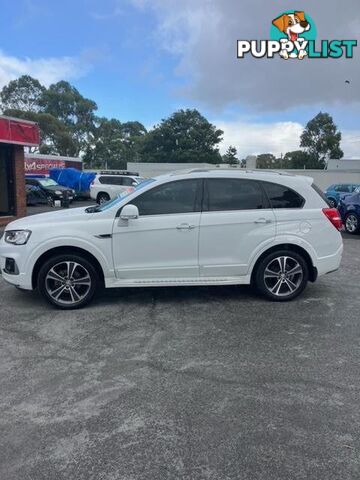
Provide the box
[0,170,343,309]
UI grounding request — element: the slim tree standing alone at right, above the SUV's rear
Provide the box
[300,112,344,168]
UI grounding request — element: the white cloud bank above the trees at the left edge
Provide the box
[0,50,91,88]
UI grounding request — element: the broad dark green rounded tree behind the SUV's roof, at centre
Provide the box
[139,110,224,163]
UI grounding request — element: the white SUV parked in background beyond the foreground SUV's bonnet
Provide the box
[90,170,144,205]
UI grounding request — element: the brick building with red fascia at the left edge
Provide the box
[0,116,40,225]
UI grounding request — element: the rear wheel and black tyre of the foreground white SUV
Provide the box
[254,250,309,302]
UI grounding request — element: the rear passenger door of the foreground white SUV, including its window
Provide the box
[199,178,276,277]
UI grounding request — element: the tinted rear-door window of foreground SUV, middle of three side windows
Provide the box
[204,178,267,212]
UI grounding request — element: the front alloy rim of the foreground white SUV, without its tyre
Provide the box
[45,261,91,305]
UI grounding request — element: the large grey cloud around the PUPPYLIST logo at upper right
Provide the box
[132,0,360,111]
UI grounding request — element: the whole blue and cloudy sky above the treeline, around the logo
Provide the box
[0,0,360,158]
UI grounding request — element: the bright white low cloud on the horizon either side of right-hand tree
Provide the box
[212,120,360,158]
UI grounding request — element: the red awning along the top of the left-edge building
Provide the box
[0,117,40,147]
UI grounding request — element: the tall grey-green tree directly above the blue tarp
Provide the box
[40,81,97,155]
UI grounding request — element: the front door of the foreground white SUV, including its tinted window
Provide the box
[113,179,202,280]
